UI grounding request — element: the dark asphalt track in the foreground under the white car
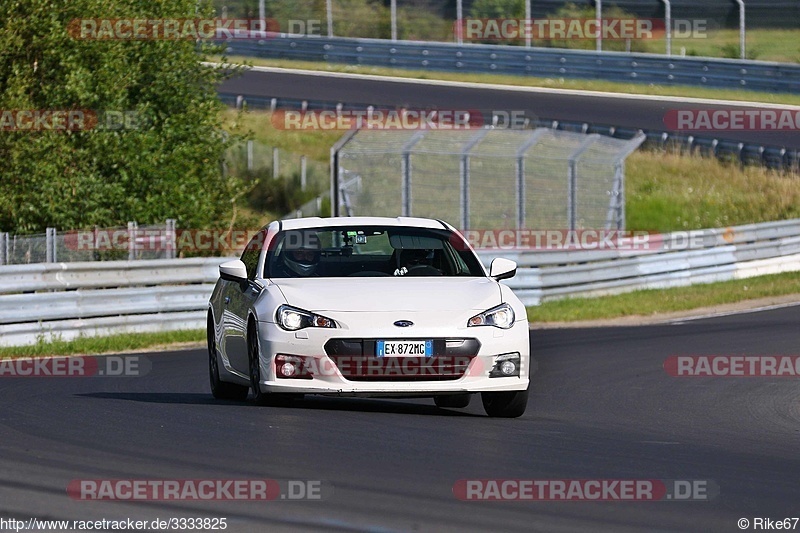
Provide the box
[0,306,800,532]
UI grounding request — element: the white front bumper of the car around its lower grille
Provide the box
[259,321,530,396]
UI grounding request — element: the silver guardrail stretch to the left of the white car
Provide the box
[0,257,225,346]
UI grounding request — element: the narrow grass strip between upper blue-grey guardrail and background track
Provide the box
[212,56,800,105]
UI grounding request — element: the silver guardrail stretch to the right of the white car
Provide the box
[478,220,800,305]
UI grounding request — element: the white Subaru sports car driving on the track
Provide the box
[208,217,530,417]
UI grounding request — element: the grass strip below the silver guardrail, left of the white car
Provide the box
[0,329,206,358]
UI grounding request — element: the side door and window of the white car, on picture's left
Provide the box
[222,230,265,375]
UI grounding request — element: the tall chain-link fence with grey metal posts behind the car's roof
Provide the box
[332,128,644,230]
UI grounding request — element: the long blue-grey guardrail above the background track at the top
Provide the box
[225,34,800,93]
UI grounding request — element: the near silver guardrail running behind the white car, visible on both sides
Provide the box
[0,219,800,346]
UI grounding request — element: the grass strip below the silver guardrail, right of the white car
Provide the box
[528,272,800,322]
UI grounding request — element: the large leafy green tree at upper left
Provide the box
[0,0,244,233]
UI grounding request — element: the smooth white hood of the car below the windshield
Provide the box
[273,277,501,313]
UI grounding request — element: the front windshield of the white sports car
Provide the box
[264,226,485,278]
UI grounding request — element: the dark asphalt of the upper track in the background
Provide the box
[220,70,800,150]
